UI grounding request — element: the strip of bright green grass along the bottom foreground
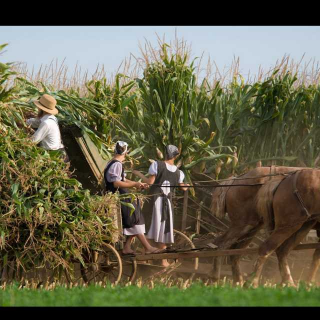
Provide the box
[0,284,320,306]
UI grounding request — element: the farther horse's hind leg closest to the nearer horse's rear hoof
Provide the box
[230,222,263,285]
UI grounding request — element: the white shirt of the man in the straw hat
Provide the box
[27,114,64,150]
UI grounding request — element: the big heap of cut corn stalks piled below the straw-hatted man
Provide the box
[0,104,119,278]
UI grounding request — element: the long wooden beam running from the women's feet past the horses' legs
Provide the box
[135,243,320,261]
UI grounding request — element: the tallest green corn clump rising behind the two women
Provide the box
[119,44,232,190]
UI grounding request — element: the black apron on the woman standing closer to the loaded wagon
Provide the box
[104,160,144,228]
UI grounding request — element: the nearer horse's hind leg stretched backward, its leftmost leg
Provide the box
[244,223,303,287]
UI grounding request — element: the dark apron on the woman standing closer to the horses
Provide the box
[150,161,180,233]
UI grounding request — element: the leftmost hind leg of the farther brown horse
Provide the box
[210,225,252,280]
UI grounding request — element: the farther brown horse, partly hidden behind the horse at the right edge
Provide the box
[211,166,305,283]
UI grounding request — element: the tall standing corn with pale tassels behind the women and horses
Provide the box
[9,39,320,180]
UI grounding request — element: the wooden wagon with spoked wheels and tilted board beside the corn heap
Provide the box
[42,126,198,284]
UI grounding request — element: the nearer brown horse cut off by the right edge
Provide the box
[245,169,320,287]
